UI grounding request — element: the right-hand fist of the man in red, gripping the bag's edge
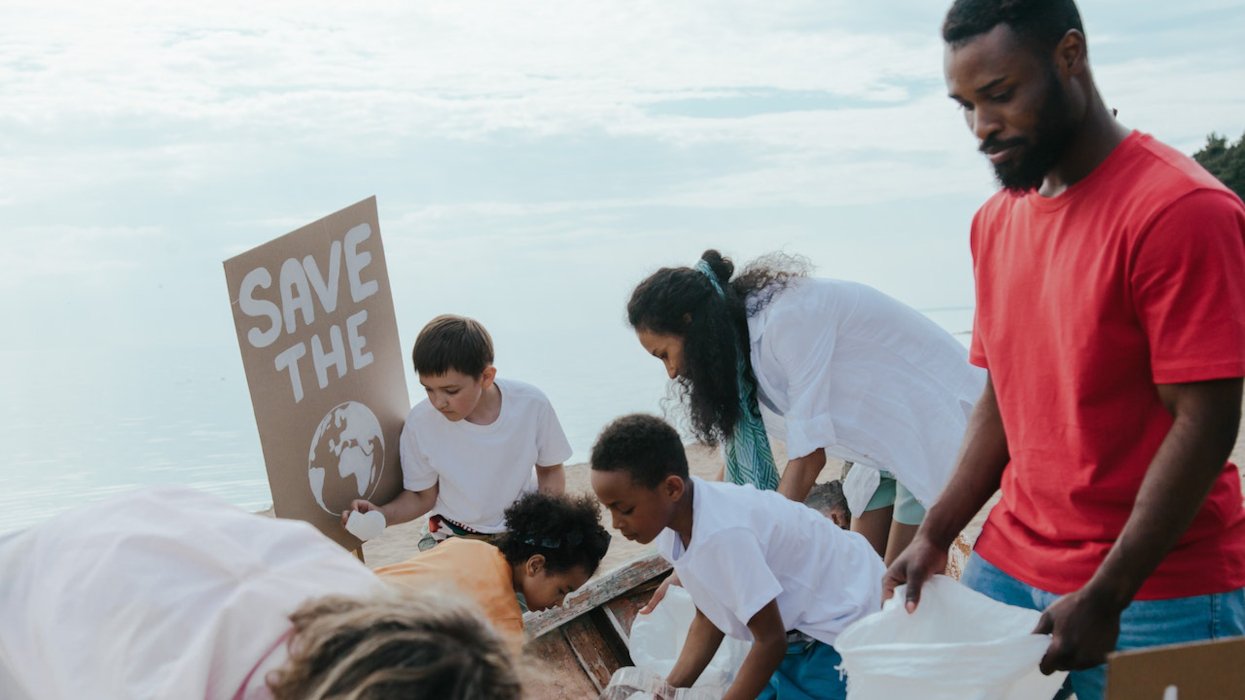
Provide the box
[1033,588,1123,675]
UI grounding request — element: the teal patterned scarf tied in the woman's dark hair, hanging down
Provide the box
[696,260,778,491]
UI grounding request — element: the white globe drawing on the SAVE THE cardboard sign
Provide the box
[308,401,385,516]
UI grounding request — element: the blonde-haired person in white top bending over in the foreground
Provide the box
[0,488,520,700]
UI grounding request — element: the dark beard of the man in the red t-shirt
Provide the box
[981,70,1076,194]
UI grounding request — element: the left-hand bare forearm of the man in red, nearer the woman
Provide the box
[919,380,1008,549]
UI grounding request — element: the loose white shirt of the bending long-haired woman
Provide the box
[748,279,986,506]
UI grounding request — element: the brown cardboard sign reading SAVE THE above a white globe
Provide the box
[224,197,411,549]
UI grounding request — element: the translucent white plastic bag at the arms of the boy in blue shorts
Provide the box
[630,585,752,688]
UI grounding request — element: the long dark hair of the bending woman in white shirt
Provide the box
[626,249,810,445]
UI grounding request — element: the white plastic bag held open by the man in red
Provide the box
[834,575,1067,700]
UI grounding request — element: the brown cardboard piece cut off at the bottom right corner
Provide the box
[1107,638,1245,700]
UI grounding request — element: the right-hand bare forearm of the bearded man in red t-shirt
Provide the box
[1086,380,1241,609]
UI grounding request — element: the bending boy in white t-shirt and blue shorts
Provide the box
[591,415,884,699]
